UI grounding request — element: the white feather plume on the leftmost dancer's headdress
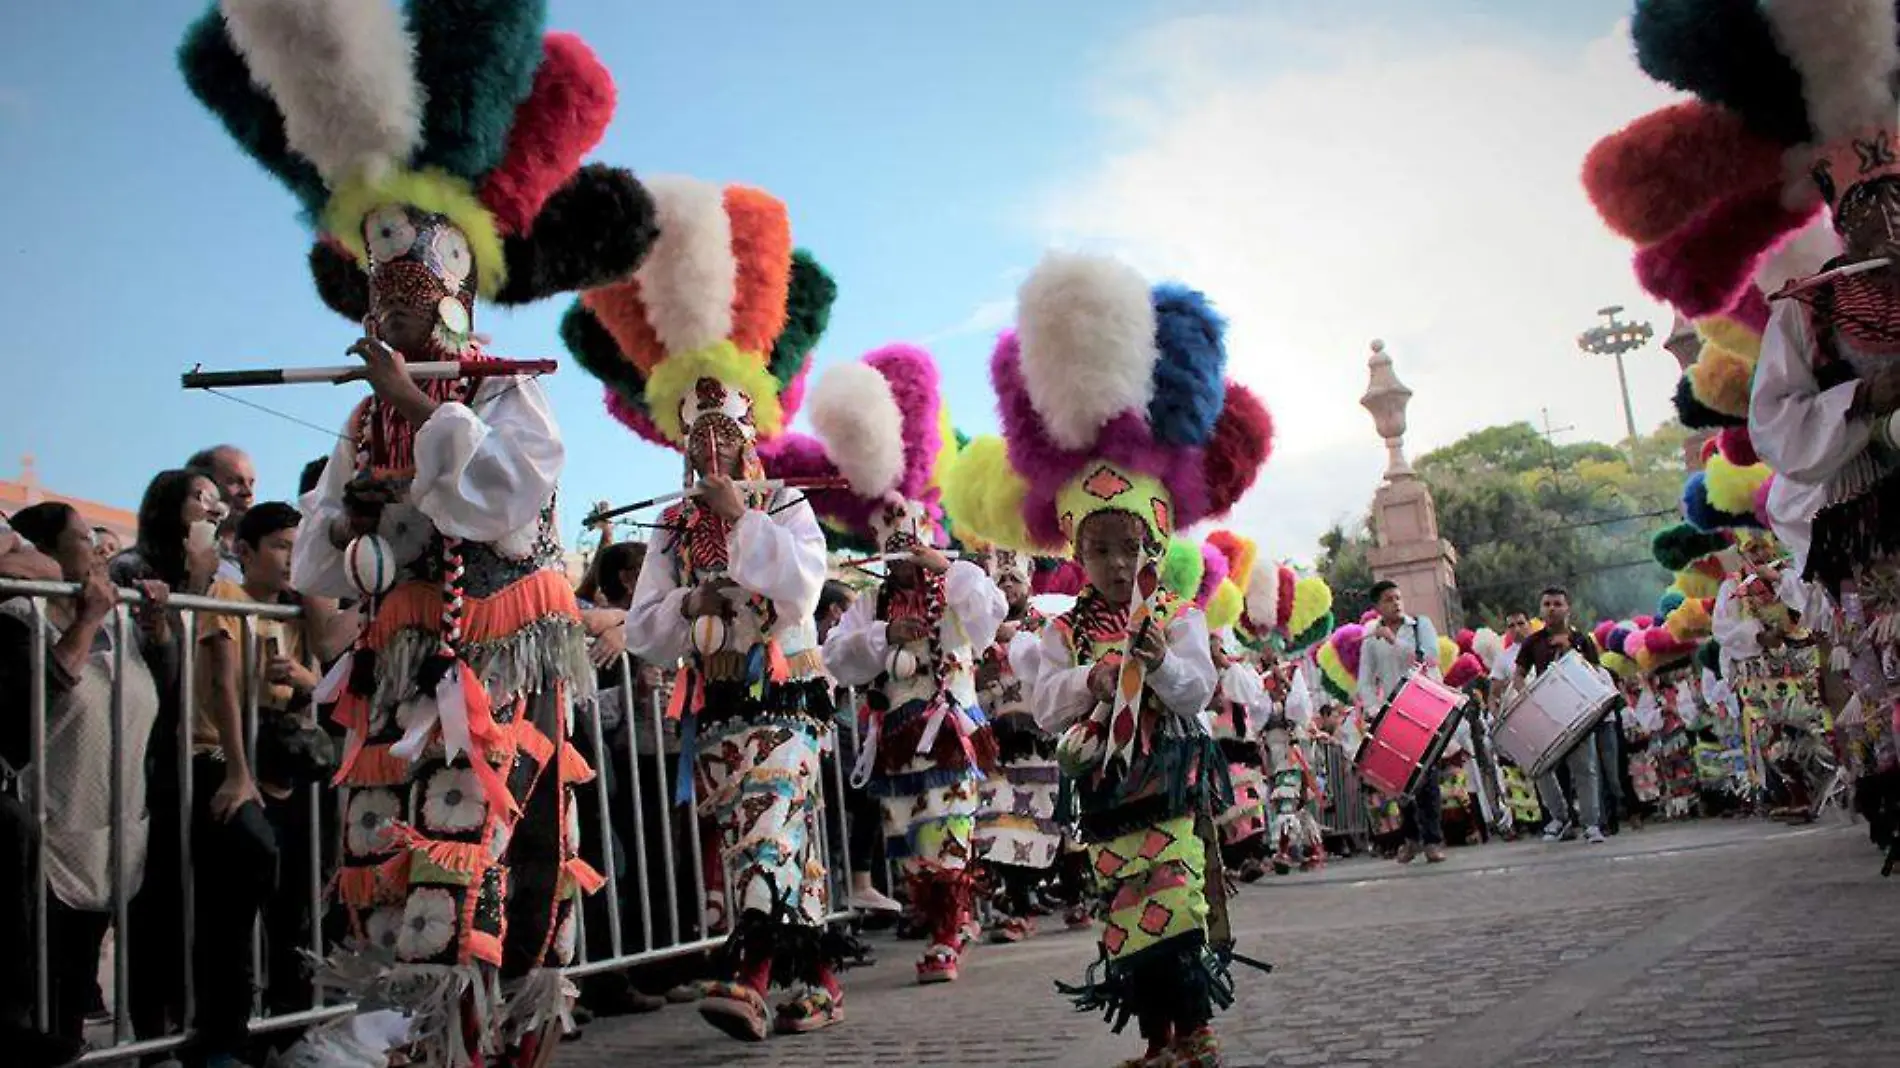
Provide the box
[220,0,422,188]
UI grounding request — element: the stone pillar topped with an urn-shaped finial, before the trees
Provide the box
[1359,340,1463,635]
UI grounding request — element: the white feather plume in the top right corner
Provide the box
[1761,0,1900,144]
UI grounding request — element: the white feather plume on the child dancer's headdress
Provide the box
[1017,253,1161,448]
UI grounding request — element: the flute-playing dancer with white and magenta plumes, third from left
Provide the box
[811,346,1009,982]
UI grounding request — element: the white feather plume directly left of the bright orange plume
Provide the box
[635,175,739,353]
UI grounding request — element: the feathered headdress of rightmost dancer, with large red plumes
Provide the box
[1585,0,1900,319]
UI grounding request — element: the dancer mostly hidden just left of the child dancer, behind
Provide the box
[977,547,1062,943]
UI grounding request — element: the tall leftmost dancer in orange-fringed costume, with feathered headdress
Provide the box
[179,0,654,1066]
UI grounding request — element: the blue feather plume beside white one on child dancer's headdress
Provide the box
[1148,285,1227,447]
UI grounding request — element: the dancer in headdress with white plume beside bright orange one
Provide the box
[562,177,847,1041]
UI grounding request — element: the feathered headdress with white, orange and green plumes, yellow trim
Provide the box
[561,177,838,450]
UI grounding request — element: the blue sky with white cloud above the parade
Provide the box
[0,0,1676,561]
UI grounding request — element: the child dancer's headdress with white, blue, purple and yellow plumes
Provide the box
[952,253,1273,553]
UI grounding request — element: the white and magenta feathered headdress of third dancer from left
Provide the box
[760,344,956,553]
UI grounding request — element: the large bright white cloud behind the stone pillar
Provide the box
[1041,13,1676,559]
